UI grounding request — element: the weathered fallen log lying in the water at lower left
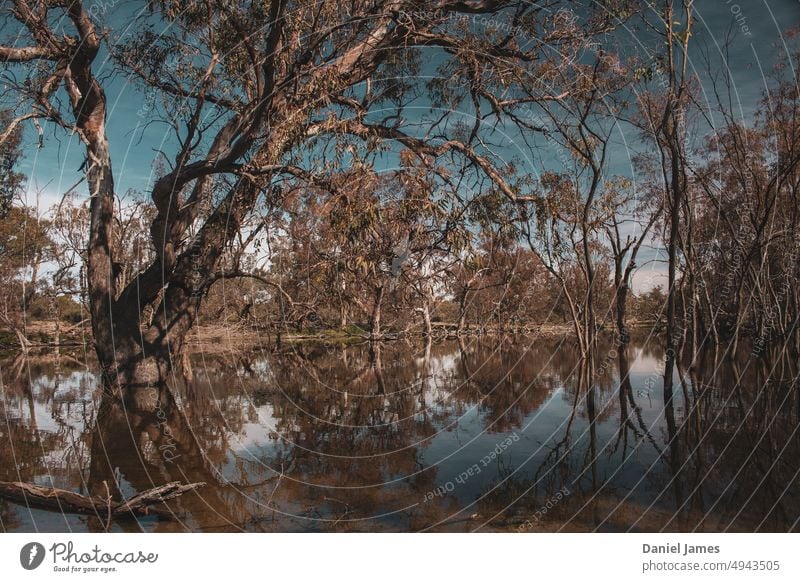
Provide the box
[0,481,205,519]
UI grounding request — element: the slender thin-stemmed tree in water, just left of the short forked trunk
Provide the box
[522,37,631,357]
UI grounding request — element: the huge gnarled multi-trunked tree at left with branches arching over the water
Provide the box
[0,0,629,389]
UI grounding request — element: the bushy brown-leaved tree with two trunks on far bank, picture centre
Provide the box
[325,168,466,339]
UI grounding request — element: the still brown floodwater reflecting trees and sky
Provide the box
[0,336,800,532]
